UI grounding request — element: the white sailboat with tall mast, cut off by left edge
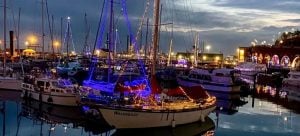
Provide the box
[0,0,22,90]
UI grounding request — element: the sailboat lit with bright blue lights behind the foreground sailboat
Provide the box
[83,0,146,96]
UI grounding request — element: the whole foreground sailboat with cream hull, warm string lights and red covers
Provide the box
[92,0,216,129]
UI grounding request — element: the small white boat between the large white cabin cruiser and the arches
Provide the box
[234,62,267,84]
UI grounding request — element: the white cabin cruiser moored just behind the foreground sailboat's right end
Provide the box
[177,68,240,92]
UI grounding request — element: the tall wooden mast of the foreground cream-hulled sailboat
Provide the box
[151,0,160,76]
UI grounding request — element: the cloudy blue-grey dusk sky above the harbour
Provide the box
[0,0,300,55]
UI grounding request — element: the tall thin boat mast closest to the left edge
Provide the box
[3,0,6,77]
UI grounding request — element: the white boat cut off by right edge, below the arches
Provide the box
[282,71,300,101]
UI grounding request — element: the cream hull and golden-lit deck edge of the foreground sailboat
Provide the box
[100,98,216,129]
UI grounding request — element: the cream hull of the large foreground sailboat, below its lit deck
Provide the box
[100,106,216,129]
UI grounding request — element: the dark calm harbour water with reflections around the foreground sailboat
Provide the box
[0,86,300,136]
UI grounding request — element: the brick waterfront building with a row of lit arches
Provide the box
[237,31,300,67]
